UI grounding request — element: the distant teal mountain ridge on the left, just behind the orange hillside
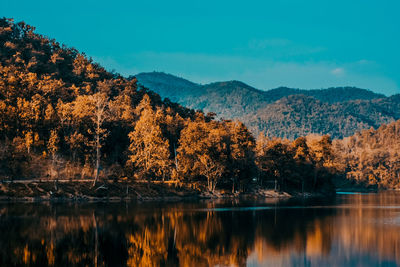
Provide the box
[135,72,270,118]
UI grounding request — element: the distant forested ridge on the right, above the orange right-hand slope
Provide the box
[245,95,400,139]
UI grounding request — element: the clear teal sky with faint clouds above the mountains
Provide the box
[0,0,400,95]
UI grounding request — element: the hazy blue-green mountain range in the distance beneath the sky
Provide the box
[135,72,400,139]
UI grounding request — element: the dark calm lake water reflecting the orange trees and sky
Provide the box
[0,192,400,266]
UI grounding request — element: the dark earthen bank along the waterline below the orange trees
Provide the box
[0,180,308,202]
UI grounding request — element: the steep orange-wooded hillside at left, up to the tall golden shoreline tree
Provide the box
[0,18,195,182]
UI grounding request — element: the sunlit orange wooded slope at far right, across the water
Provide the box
[334,120,400,188]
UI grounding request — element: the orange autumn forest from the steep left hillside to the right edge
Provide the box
[0,18,399,197]
